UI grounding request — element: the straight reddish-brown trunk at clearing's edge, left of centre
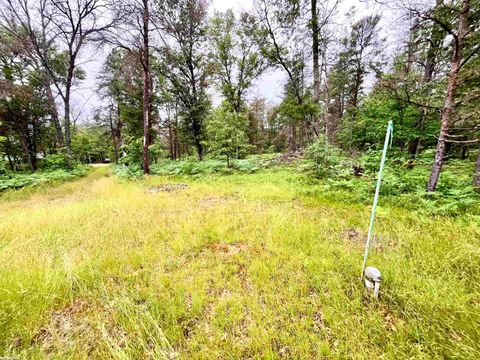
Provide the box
[142,0,150,174]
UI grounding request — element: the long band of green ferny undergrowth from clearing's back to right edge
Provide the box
[114,149,480,216]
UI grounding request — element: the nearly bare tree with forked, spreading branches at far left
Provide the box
[3,0,113,153]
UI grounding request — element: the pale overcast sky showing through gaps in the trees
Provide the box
[72,0,402,122]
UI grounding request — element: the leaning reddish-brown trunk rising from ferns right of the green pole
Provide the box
[427,0,470,192]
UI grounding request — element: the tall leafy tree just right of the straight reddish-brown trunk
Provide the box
[156,0,212,161]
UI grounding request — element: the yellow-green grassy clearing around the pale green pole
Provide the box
[0,167,480,359]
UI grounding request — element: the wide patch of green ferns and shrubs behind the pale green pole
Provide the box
[304,147,480,216]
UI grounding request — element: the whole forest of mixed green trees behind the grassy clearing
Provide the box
[0,0,480,192]
